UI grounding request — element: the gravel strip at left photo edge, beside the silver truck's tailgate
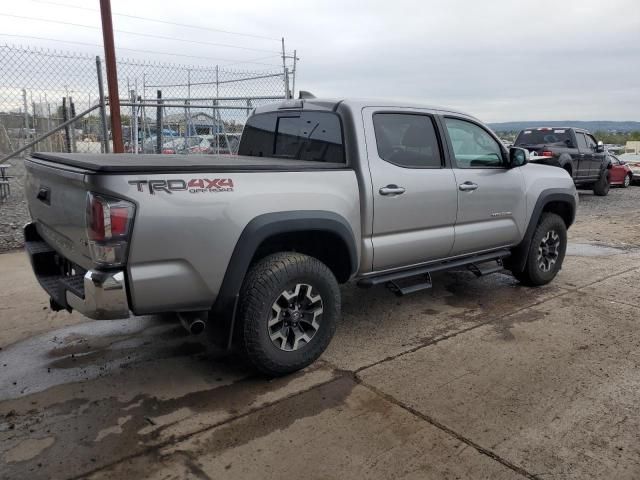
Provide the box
[0,158,29,253]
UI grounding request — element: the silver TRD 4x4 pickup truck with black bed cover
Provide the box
[25,99,578,375]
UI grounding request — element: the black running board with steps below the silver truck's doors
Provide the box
[358,249,511,295]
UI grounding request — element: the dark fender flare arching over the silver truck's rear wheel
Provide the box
[213,210,358,316]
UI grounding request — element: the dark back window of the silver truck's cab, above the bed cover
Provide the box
[238,112,345,163]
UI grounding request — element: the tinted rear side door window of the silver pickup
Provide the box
[373,113,442,168]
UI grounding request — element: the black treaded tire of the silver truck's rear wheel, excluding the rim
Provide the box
[237,252,340,376]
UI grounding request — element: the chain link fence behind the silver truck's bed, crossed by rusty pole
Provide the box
[0,44,289,161]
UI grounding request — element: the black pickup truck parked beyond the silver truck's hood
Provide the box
[515,127,611,196]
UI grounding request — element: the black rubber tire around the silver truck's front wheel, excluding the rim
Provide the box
[512,212,567,287]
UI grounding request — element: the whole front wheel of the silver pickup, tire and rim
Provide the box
[513,213,567,287]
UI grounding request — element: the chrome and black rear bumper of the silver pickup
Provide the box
[24,223,129,320]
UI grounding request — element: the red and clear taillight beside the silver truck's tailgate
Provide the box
[87,193,135,267]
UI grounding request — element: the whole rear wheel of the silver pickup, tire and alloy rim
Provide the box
[238,252,340,376]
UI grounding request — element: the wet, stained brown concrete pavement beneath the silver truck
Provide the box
[0,189,640,479]
